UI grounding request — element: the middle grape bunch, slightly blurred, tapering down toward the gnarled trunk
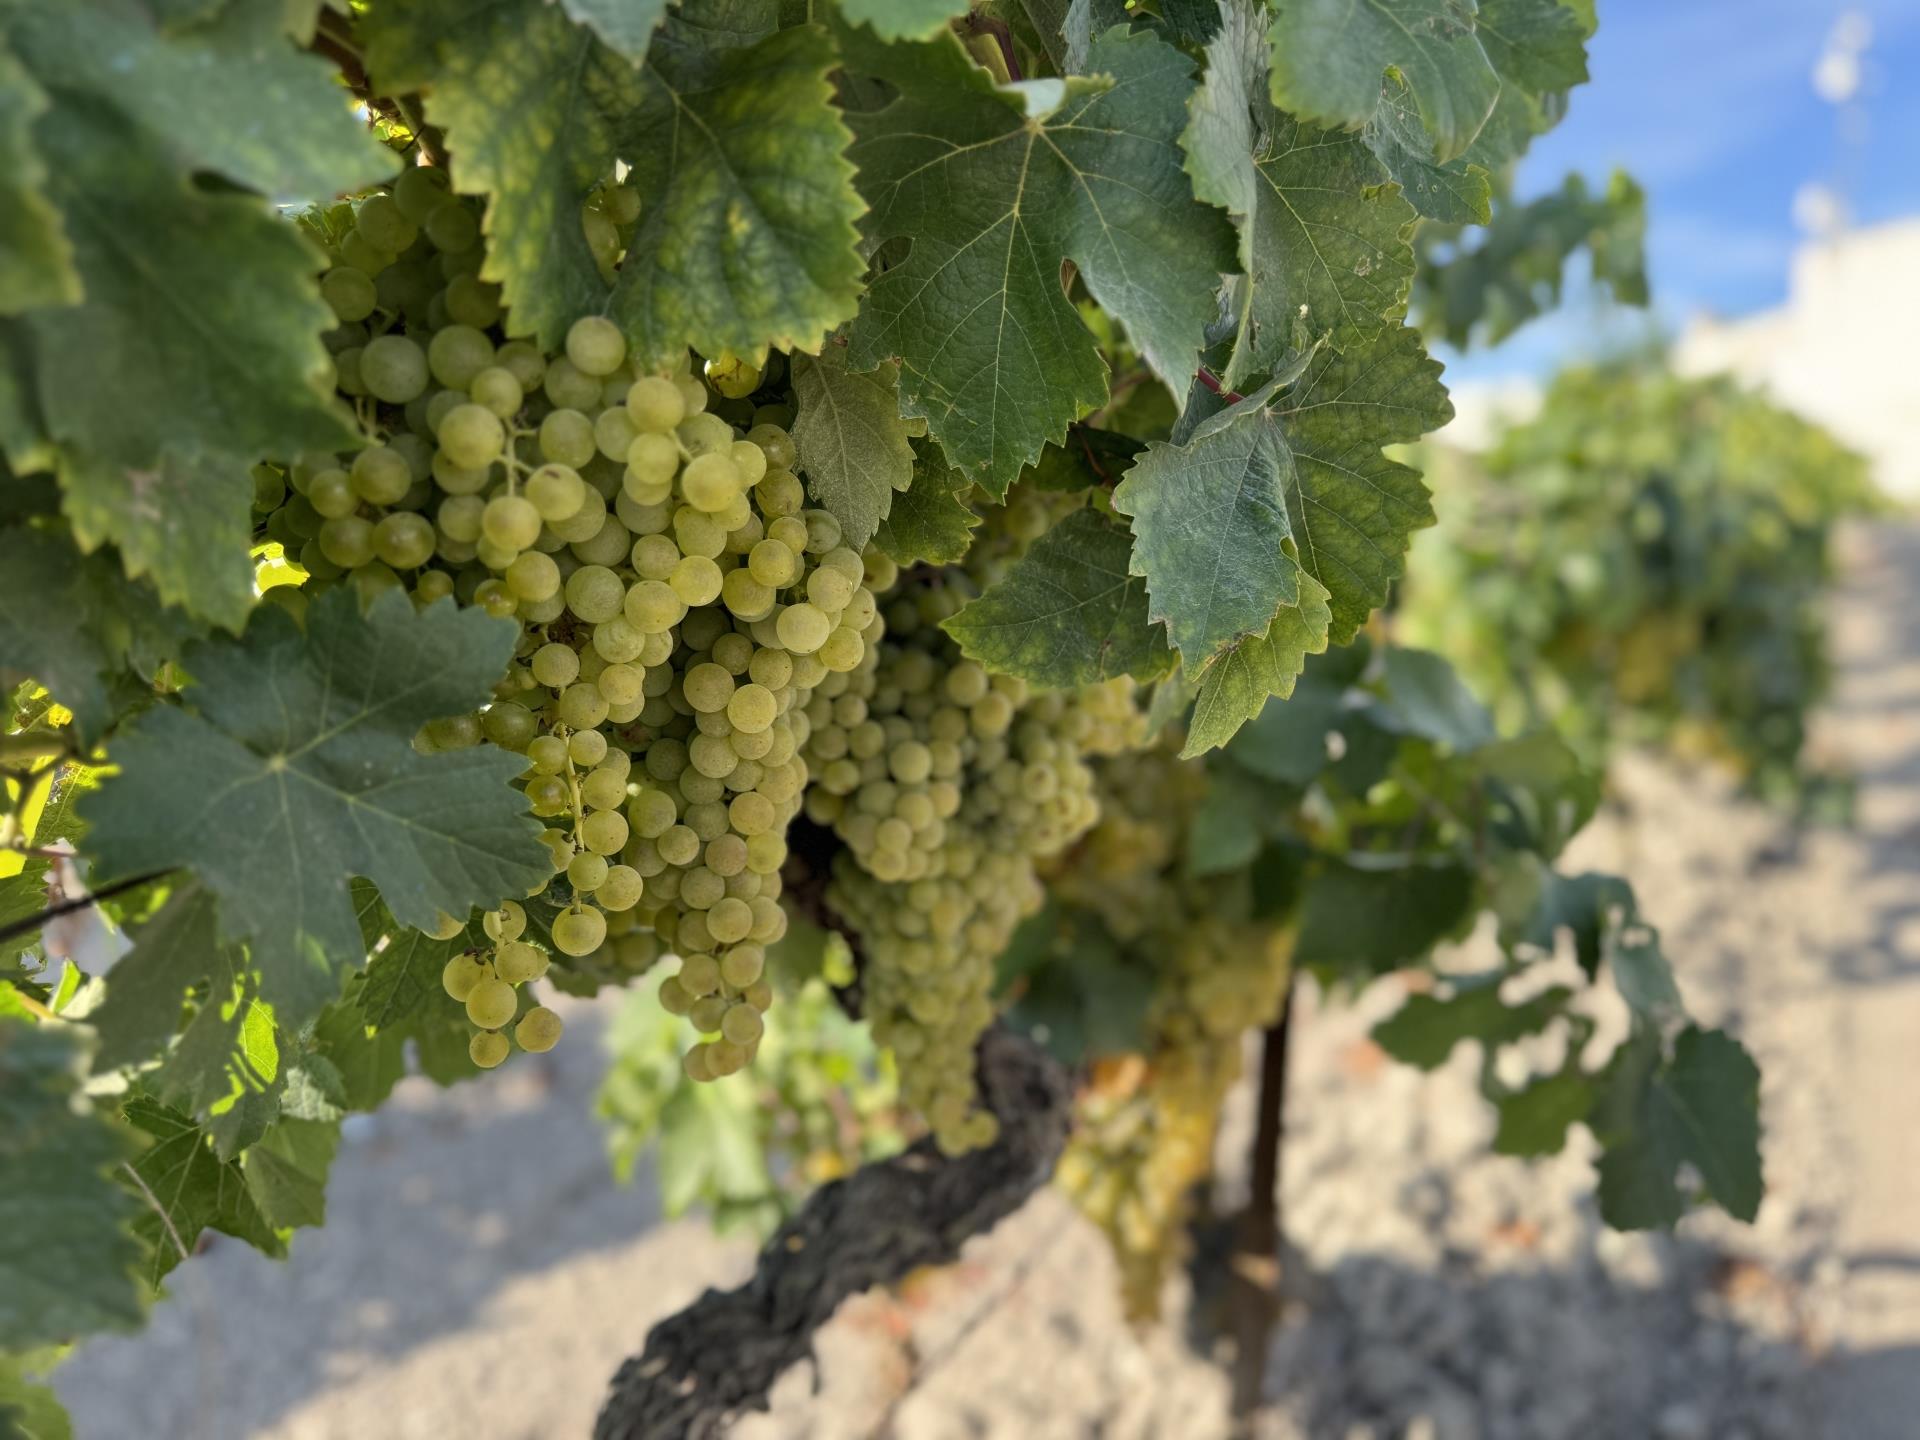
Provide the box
[804,526,1144,1152]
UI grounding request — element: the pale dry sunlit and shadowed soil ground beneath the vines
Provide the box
[58,528,1920,1440]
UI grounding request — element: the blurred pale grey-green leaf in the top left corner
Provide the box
[10,0,394,204]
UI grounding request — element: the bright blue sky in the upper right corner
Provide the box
[1448,0,1920,378]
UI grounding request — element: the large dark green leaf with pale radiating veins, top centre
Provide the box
[839,27,1233,497]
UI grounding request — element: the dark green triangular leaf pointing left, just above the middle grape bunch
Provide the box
[941,509,1175,687]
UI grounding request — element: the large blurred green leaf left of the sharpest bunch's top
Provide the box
[31,102,355,628]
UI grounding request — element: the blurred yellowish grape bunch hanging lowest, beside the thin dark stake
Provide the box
[1048,745,1292,1317]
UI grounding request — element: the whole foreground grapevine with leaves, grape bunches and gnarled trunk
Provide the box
[0,0,1774,1436]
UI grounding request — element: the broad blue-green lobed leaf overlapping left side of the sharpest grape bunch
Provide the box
[83,589,551,1029]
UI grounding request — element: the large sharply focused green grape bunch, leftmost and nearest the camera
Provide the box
[255,167,883,1079]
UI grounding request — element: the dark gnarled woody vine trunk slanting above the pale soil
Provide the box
[593,1025,1073,1440]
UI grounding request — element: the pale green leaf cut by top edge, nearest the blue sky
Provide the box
[1267,0,1500,163]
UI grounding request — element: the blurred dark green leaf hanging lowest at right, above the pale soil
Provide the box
[1599,1025,1763,1231]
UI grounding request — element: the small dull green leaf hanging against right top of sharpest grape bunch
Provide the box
[793,346,914,549]
